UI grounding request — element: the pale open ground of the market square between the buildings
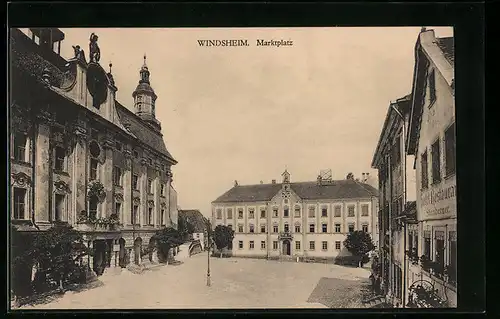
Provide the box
[18,253,369,309]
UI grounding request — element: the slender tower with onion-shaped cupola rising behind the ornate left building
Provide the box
[132,54,161,131]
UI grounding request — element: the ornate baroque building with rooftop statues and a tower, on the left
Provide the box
[9,28,177,274]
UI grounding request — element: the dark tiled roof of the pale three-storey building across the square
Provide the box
[213,180,378,203]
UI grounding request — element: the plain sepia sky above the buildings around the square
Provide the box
[22,27,453,216]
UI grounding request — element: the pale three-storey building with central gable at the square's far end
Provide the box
[212,170,378,259]
